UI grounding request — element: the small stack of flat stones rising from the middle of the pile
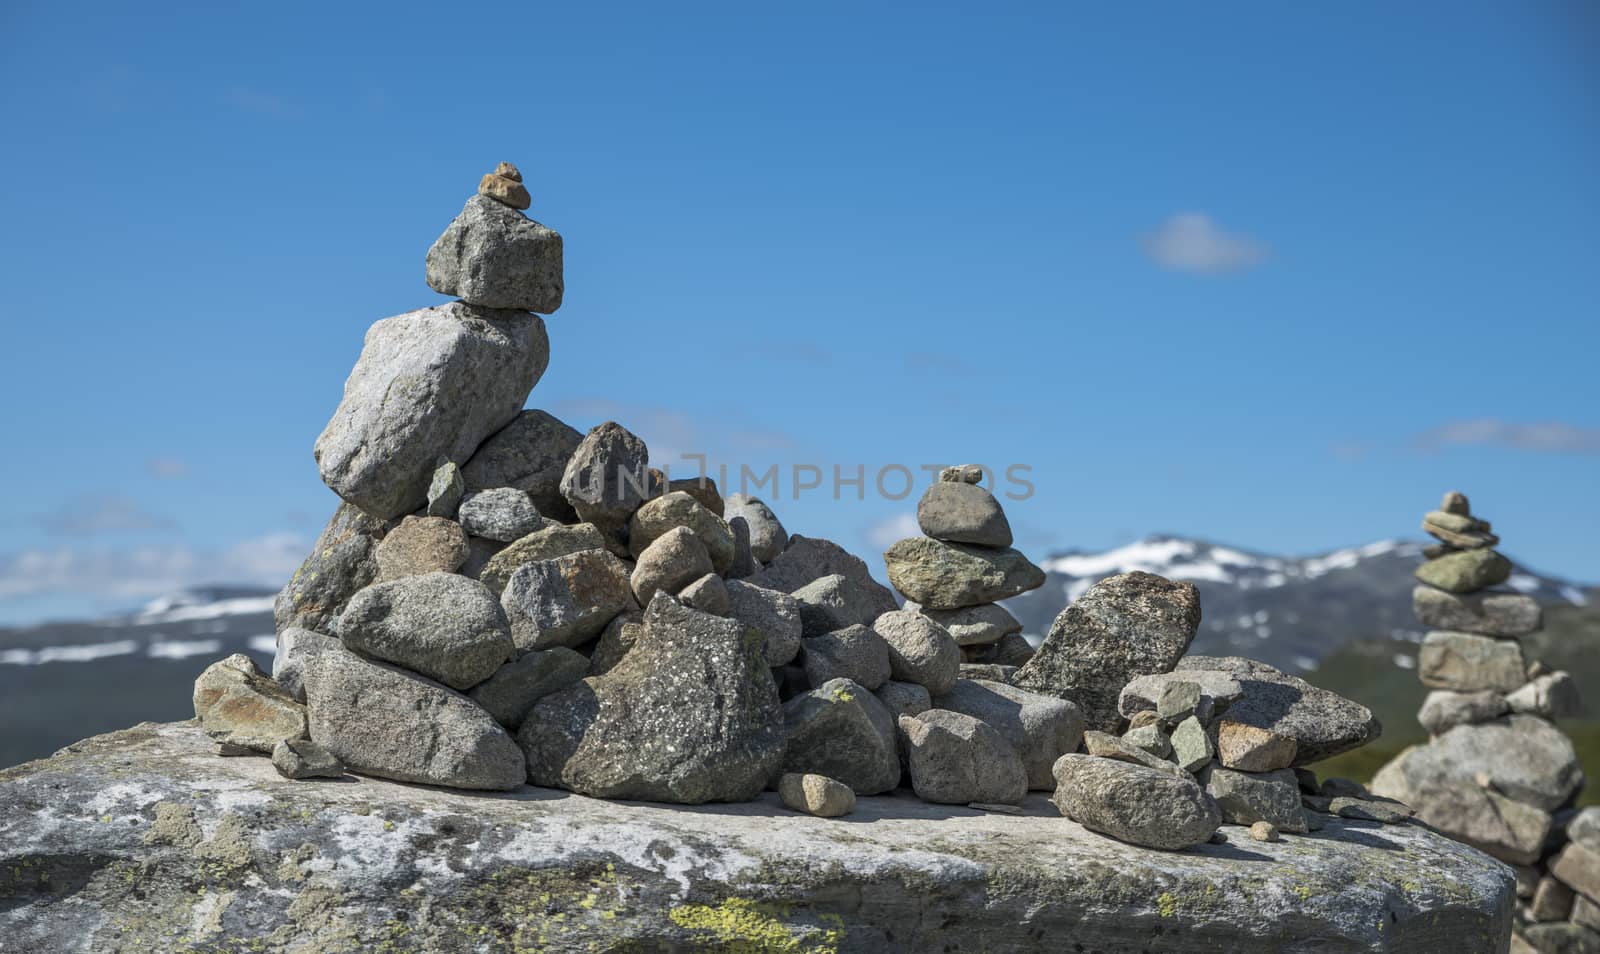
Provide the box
[883,464,1045,682]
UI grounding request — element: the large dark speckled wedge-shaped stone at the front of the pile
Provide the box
[517,594,784,805]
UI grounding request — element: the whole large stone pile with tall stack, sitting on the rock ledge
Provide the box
[194,163,1406,848]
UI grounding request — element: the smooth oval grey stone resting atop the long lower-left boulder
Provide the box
[339,573,512,690]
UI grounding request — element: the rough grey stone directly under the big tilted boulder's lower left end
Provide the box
[272,503,387,634]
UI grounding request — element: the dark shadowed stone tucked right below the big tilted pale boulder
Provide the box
[461,410,584,523]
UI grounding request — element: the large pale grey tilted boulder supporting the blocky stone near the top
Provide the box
[315,301,550,520]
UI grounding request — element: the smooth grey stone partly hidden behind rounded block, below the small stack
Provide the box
[933,679,1083,791]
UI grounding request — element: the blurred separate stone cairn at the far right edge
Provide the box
[1373,491,1600,951]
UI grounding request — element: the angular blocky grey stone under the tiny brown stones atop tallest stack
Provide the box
[427,195,565,315]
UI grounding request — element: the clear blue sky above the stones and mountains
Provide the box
[0,2,1600,621]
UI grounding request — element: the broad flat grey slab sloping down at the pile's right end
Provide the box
[1178,656,1382,765]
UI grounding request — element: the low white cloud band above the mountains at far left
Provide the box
[0,533,310,600]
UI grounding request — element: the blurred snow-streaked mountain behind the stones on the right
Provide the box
[1006,536,1589,671]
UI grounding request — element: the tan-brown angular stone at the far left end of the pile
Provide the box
[194,653,306,754]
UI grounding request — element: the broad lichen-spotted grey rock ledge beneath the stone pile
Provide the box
[0,724,1514,954]
